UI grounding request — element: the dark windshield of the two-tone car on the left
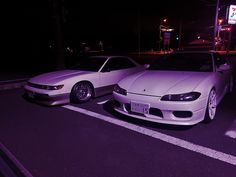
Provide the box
[70,57,107,71]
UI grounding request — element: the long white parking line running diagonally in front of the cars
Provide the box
[62,105,236,165]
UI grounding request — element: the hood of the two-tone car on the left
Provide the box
[29,70,92,85]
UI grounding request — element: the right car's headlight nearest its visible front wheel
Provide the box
[161,92,201,101]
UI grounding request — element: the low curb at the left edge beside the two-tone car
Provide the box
[0,78,28,91]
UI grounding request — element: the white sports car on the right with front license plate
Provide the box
[113,51,233,125]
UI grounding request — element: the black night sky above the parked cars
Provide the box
[2,0,236,71]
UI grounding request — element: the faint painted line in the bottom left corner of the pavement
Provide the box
[0,142,33,177]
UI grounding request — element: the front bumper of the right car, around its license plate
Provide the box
[113,92,207,125]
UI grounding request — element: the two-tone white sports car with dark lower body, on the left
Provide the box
[24,56,145,105]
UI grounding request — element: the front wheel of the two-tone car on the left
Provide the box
[70,82,93,103]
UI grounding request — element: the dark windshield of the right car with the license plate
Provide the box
[149,53,213,72]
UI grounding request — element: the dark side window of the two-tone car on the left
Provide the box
[102,57,136,72]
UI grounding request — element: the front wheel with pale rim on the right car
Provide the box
[204,89,216,123]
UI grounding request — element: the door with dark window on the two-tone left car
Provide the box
[100,57,139,88]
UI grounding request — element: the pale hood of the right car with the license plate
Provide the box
[119,71,211,96]
